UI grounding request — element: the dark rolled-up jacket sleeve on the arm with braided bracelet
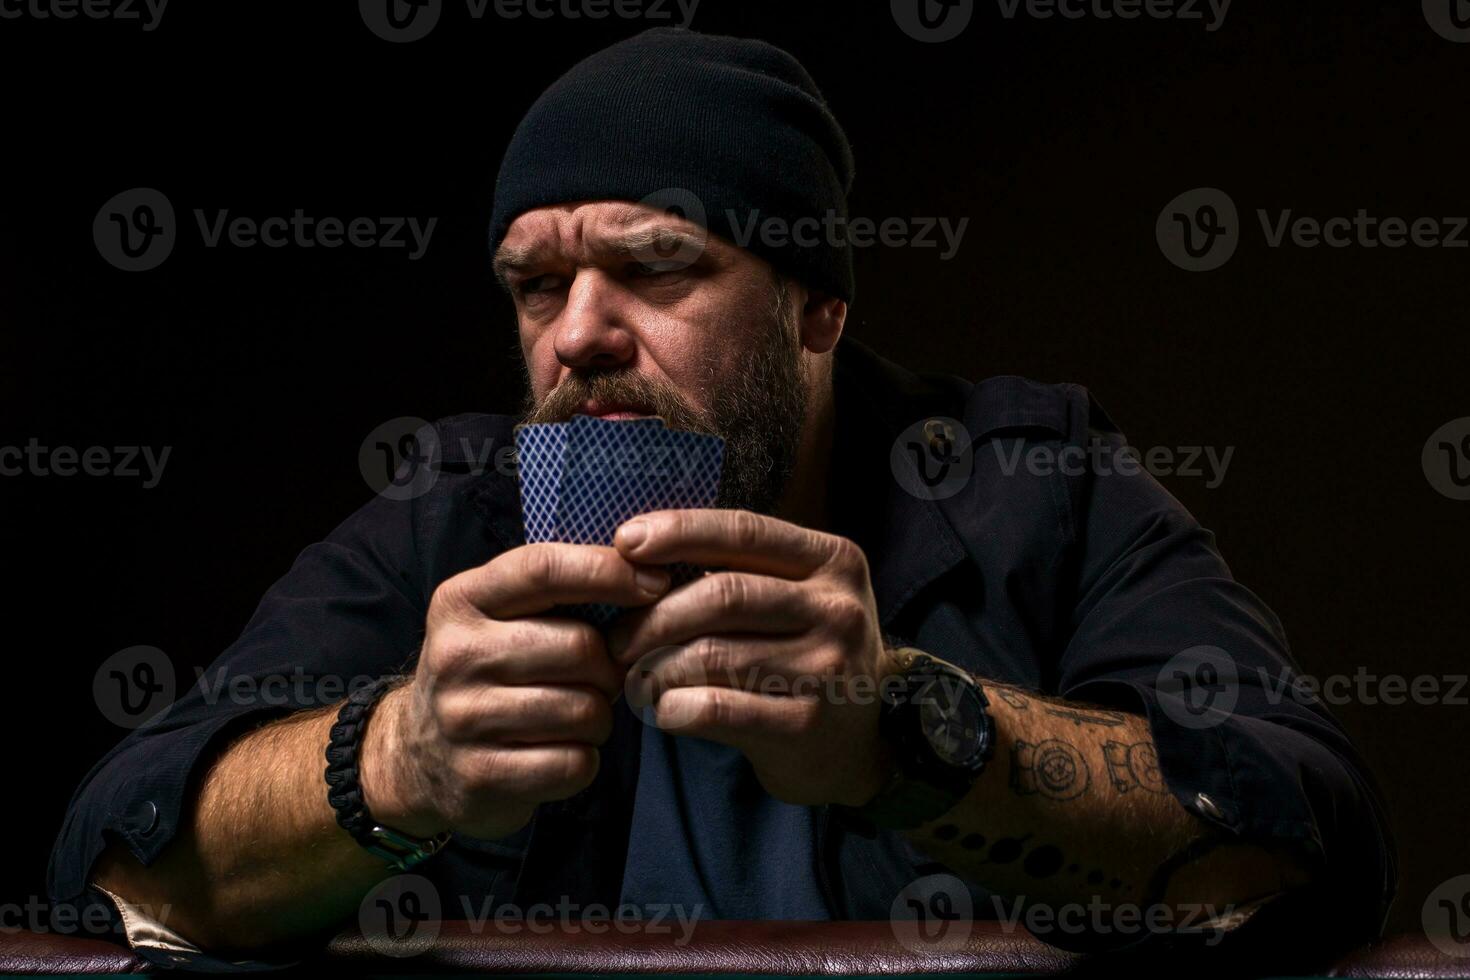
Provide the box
[47,487,426,968]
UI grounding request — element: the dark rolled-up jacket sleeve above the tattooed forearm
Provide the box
[1055,393,1397,937]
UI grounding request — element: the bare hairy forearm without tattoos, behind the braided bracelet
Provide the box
[94,692,398,952]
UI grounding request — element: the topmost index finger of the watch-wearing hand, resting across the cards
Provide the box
[613,508,836,579]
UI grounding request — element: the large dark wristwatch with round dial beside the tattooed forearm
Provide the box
[833,646,995,836]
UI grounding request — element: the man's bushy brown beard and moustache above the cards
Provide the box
[522,284,807,514]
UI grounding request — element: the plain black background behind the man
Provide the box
[0,0,1470,930]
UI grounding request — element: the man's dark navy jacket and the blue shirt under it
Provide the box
[49,338,1397,963]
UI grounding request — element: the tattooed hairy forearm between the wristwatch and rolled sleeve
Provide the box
[910,682,1302,928]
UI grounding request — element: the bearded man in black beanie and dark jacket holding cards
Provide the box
[50,29,1395,968]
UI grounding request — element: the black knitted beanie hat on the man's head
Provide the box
[490,28,853,303]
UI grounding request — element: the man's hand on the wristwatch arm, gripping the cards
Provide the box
[607,510,891,805]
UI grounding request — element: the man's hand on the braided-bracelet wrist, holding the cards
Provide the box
[362,544,669,839]
